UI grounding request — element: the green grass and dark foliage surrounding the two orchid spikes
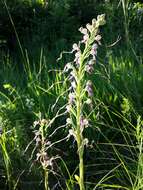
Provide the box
[0,0,143,190]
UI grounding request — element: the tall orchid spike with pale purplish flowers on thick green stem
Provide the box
[64,14,105,190]
